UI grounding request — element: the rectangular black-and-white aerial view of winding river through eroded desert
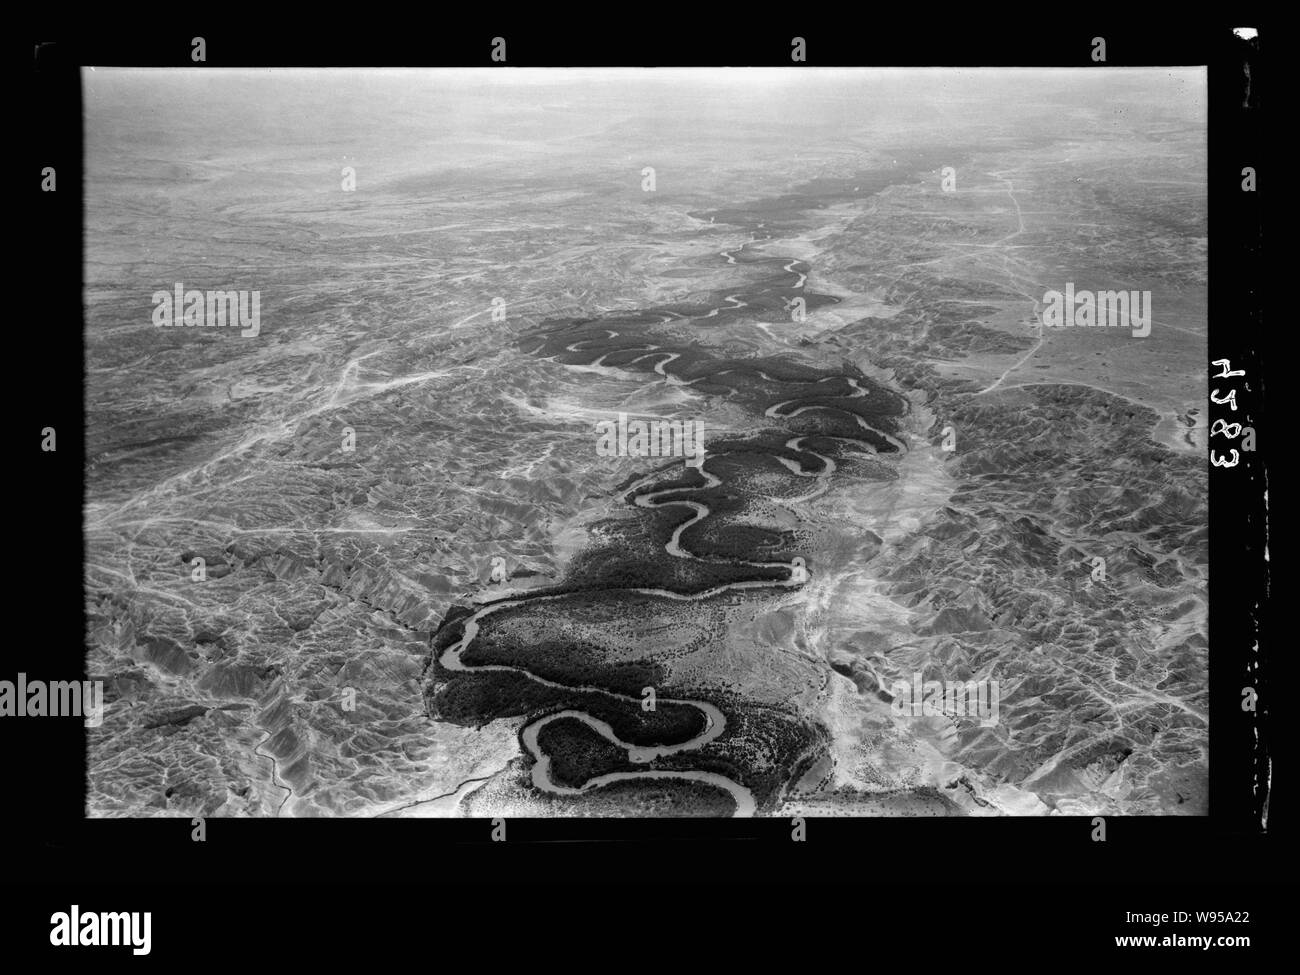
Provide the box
[83,66,1210,819]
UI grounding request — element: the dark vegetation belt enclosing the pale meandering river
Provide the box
[425,170,909,815]
